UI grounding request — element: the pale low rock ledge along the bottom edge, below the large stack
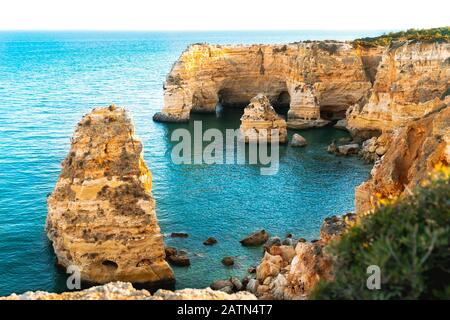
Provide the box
[0,282,256,300]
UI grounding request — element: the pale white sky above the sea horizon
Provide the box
[0,0,450,30]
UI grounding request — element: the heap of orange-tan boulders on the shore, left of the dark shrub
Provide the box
[246,213,356,300]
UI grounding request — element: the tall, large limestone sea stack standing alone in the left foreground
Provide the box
[46,105,174,285]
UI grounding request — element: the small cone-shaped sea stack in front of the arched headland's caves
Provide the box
[240,94,287,143]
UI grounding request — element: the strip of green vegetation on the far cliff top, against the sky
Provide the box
[353,27,450,47]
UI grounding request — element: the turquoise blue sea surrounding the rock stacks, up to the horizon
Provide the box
[0,31,381,295]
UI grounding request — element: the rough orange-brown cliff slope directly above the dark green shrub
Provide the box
[355,107,450,212]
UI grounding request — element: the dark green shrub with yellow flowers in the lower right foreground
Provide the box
[310,167,450,299]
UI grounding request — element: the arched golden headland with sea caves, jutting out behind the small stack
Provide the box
[155,42,381,127]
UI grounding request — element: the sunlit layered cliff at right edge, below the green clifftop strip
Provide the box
[347,42,450,137]
